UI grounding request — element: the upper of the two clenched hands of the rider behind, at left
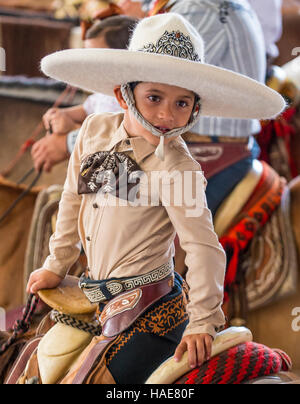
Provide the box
[43,108,78,134]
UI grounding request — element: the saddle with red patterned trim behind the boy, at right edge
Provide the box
[215,161,297,316]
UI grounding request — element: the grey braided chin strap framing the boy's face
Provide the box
[121,83,201,161]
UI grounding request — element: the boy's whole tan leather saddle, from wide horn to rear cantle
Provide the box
[8,276,258,384]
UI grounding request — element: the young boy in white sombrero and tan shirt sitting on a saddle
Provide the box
[27,13,284,383]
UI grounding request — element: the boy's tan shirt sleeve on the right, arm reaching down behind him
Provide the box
[161,165,226,338]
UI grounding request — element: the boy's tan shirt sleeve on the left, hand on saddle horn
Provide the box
[43,114,89,277]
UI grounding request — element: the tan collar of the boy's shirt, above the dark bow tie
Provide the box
[107,122,156,164]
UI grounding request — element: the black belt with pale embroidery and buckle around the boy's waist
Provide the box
[78,259,174,303]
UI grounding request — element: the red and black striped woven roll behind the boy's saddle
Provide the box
[176,342,290,384]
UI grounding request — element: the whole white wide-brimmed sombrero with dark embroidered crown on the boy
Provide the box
[41,13,285,119]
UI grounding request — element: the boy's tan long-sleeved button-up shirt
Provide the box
[44,114,226,337]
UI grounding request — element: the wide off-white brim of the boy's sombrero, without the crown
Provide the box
[41,49,285,119]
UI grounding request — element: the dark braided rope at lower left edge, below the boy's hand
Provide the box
[0,294,39,356]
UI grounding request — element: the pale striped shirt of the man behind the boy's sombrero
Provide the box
[171,0,266,137]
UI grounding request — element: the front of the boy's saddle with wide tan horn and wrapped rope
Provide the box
[13,275,174,384]
